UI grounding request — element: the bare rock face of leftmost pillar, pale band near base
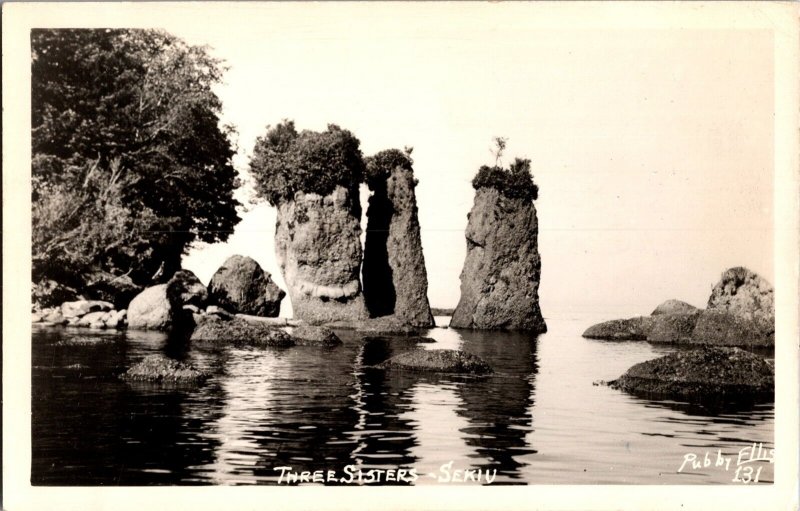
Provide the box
[275,186,367,322]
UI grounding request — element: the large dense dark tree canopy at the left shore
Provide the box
[31,29,239,298]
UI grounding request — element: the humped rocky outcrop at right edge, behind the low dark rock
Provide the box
[583,268,775,347]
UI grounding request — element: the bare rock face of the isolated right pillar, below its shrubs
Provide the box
[450,188,547,333]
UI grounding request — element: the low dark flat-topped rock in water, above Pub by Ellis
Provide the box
[609,347,775,402]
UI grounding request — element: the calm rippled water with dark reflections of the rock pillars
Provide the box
[31,315,774,485]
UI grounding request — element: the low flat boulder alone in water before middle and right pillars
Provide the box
[378,349,492,374]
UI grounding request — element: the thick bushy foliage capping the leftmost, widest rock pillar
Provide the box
[250,120,364,205]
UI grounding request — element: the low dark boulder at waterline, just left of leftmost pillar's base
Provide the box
[190,318,296,347]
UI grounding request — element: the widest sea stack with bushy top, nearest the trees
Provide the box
[250,121,368,323]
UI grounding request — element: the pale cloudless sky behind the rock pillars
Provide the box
[169,4,774,317]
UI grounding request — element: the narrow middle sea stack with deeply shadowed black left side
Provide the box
[362,149,434,327]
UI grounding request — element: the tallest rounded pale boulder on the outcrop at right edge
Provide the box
[707,267,775,336]
